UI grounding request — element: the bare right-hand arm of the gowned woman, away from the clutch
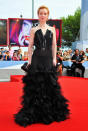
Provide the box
[52,27,57,66]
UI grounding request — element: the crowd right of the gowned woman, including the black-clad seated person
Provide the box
[57,48,88,77]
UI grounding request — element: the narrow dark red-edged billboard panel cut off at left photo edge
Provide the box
[0,19,7,46]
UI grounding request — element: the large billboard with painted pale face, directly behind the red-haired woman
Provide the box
[8,18,62,47]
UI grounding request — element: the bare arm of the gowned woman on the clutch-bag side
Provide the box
[28,28,34,64]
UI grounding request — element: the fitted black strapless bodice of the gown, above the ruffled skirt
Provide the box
[31,29,53,69]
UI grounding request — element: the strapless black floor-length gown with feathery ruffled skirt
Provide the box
[14,29,70,127]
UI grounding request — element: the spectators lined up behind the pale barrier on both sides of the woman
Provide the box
[0,47,88,61]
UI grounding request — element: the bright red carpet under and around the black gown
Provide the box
[0,75,88,131]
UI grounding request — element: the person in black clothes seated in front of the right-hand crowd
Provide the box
[71,49,85,77]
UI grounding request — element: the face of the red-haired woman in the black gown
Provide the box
[38,9,48,22]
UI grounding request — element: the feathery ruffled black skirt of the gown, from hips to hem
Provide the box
[14,65,70,127]
